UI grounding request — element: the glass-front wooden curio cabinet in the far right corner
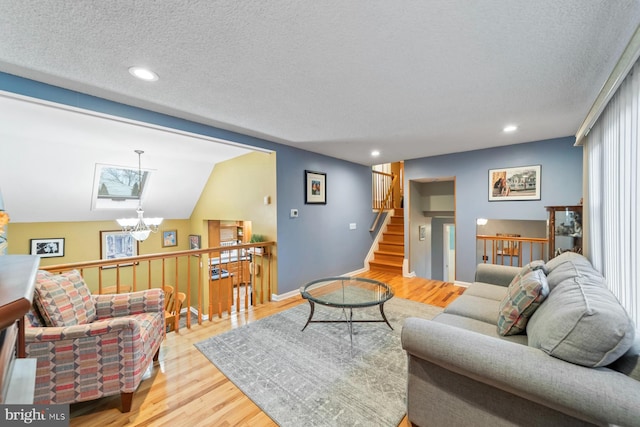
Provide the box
[545,205,582,259]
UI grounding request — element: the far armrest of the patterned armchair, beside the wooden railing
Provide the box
[91,288,164,319]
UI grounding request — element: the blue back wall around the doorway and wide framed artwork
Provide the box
[404,137,582,282]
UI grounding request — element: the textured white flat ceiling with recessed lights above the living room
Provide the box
[0,0,640,222]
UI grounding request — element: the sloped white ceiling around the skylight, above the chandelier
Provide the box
[0,94,252,222]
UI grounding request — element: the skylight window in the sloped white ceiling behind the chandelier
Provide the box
[92,164,151,209]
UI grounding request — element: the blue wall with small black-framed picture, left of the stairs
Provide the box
[276,147,375,293]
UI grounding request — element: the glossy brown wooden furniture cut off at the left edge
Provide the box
[0,255,40,403]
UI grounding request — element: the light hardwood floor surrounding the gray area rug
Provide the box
[70,272,465,427]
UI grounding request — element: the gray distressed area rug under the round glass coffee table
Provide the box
[195,298,442,427]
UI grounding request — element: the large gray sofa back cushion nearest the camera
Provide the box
[527,254,635,367]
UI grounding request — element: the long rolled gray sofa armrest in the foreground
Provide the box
[402,318,640,425]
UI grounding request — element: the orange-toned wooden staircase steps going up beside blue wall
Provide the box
[369,209,404,274]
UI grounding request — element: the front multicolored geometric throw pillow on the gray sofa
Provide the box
[498,267,549,335]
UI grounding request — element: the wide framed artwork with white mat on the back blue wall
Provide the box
[489,165,541,202]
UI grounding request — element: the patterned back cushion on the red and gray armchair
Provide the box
[34,270,96,326]
